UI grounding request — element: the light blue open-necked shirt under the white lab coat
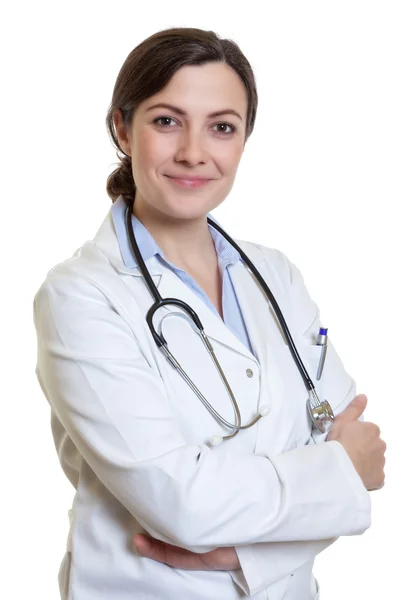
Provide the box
[111,196,254,354]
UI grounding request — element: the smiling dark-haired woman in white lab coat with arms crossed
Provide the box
[34,28,385,600]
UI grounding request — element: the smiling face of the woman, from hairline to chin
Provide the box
[109,61,248,232]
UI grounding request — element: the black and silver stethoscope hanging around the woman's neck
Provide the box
[126,204,334,446]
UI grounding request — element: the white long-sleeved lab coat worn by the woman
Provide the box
[34,206,371,600]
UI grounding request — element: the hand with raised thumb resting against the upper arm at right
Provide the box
[326,394,387,491]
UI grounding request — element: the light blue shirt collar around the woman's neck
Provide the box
[111,195,240,269]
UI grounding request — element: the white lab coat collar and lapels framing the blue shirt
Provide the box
[93,204,269,363]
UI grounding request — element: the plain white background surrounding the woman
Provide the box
[0,0,414,600]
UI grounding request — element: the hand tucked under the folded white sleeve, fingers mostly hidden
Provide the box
[134,533,240,571]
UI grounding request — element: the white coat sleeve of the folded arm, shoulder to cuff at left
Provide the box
[34,276,370,553]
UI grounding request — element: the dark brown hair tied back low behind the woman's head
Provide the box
[106,27,258,203]
